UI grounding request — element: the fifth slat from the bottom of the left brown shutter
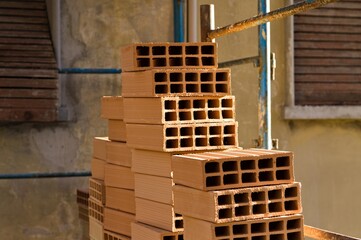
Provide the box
[0,68,58,78]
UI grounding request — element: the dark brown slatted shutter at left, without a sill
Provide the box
[0,0,58,122]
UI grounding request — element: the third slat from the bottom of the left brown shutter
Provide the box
[0,88,58,99]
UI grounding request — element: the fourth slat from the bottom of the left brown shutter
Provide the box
[0,77,58,89]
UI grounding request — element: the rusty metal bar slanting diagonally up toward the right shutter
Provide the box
[207,0,338,41]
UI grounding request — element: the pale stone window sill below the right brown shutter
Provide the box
[284,106,361,120]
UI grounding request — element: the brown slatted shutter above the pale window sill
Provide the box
[294,0,361,105]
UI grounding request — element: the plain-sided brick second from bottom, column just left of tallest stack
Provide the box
[104,208,135,236]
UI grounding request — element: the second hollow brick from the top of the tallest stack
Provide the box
[122,68,231,97]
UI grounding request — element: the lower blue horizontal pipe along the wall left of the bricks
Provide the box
[0,171,91,179]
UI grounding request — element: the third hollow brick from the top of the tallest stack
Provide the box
[124,96,235,124]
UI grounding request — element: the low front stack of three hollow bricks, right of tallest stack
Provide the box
[173,149,304,240]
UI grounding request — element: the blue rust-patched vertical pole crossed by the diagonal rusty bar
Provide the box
[258,0,272,149]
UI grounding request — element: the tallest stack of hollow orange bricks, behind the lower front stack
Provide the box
[121,43,238,240]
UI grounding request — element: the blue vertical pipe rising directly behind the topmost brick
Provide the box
[173,0,184,42]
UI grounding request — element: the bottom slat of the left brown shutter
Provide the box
[0,108,58,122]
